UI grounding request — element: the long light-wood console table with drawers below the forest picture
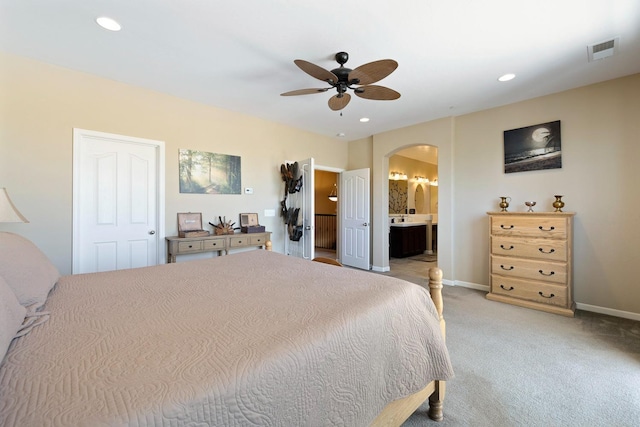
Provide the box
[166,231,271,263]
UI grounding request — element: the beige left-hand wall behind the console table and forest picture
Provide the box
[0,53,348,274]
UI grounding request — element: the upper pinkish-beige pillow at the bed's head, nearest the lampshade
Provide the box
[0,232,60,310]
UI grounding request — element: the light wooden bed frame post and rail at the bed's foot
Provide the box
[371,267,446,427]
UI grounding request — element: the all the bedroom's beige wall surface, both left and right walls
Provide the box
[0,50,640,317]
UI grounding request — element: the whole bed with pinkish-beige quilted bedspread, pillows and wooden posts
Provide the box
[0,233,453,426]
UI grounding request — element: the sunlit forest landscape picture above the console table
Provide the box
[179,149,242,194]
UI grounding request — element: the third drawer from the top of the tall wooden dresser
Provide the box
[491,256,567,285]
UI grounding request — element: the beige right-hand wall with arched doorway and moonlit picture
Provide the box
[372,74,640,319]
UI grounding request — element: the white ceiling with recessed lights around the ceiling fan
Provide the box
[0,0,640,140]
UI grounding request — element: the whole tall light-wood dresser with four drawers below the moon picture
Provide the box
[487,212,575,317]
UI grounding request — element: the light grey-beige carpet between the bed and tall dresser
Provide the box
[404,282,640,427]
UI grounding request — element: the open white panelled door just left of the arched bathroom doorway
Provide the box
[338,169,371,270]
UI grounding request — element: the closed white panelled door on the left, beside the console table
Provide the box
[72,129,164,274]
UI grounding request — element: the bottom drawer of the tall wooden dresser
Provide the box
[491,274,567,307]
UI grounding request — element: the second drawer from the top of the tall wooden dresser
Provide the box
[491,236,569,262]
